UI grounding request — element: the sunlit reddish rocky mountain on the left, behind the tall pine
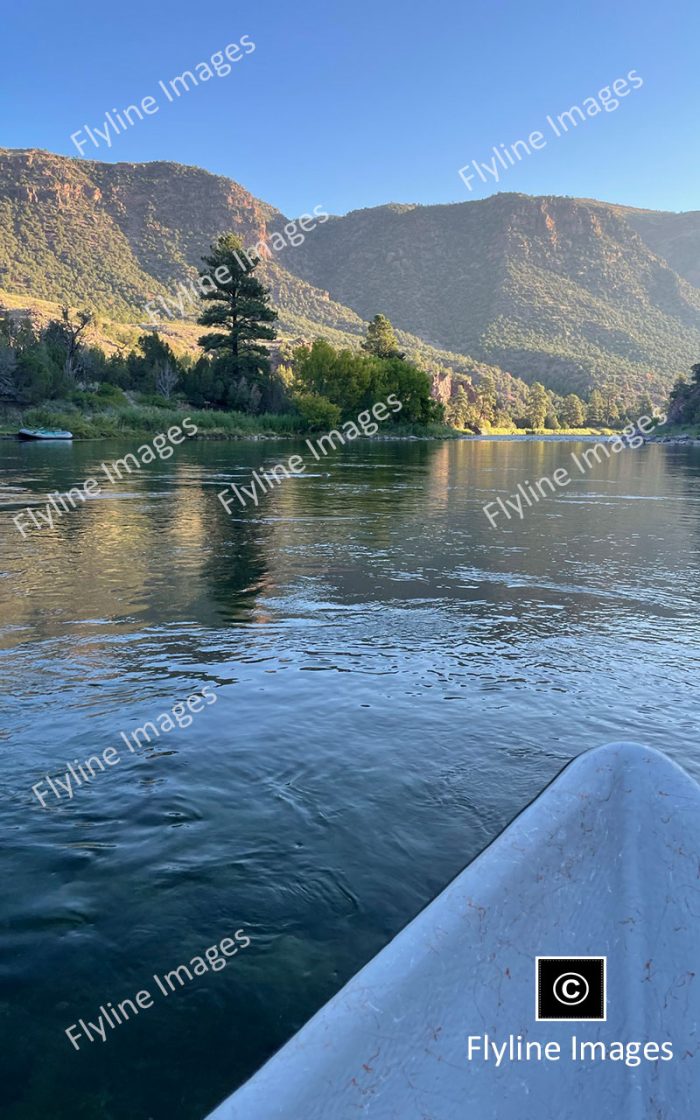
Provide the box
[0,149,526,401]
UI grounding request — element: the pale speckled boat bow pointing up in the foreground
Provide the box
[204,744,700,1120]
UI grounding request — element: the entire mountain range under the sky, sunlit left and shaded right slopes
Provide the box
[0,149,700,399]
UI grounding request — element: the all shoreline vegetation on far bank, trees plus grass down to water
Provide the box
[0,226,700,440]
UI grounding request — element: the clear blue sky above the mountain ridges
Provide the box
[0,0,700,216]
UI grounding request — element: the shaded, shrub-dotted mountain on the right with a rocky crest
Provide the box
[292,194,700,392]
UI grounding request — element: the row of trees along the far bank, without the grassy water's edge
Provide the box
[0,234,667,432]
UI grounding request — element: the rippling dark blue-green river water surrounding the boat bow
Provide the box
[0,440,700,1120]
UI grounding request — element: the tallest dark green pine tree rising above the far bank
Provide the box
[197,233,278,396]
